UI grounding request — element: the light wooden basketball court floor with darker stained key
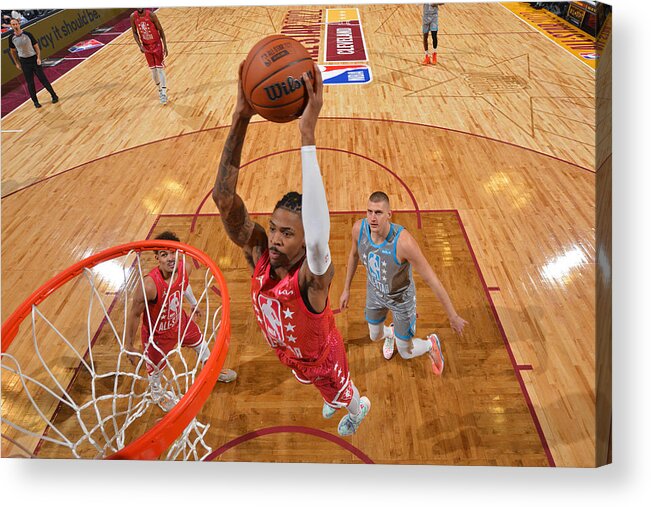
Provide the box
[2,4,595,466]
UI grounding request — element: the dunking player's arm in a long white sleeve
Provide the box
[299,66,334,311]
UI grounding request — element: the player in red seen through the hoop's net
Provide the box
[126,231,237,411]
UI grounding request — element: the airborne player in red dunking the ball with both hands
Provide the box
[213,64,371,436]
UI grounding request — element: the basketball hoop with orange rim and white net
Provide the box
[0,240,230,460]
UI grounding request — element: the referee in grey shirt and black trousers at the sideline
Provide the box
[9,18,59,107]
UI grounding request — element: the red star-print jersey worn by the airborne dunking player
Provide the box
[251,251,343,368]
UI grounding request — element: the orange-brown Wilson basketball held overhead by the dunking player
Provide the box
[242,35,314,123]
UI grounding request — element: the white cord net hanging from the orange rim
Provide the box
[1,251,221,460]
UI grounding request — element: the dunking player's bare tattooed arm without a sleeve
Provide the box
[212,62,267,268]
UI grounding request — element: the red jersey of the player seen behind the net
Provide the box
[142,260,188,335]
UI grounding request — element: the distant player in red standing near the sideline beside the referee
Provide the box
[131,9,167,104]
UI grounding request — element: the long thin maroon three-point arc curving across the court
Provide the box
[0,116,596,199]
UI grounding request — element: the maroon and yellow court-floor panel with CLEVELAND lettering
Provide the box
[325,9,368,62]
